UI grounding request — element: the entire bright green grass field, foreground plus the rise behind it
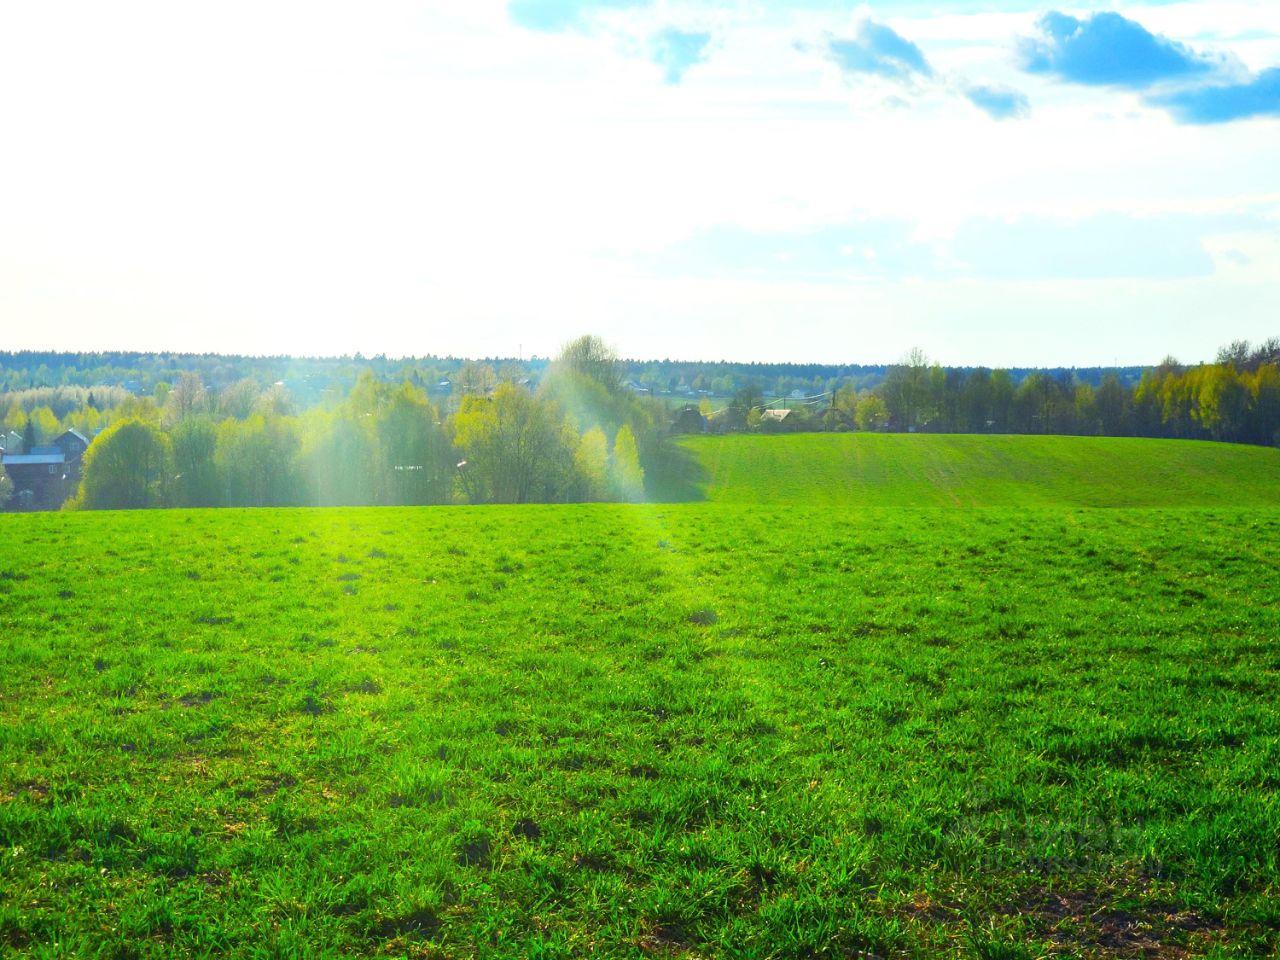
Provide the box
[0,436,1280,957]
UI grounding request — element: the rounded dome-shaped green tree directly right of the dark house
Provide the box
[73,419,173,509]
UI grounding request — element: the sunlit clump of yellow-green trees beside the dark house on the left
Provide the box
[67,337,666,509]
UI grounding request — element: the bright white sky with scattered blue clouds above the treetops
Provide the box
[0,0,1280,366]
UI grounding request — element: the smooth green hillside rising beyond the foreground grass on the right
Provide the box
[682,434,1280,507]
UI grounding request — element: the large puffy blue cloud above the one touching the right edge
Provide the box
[1019,12,1221,90]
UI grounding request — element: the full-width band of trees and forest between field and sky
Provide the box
[0,337,1280,509]
